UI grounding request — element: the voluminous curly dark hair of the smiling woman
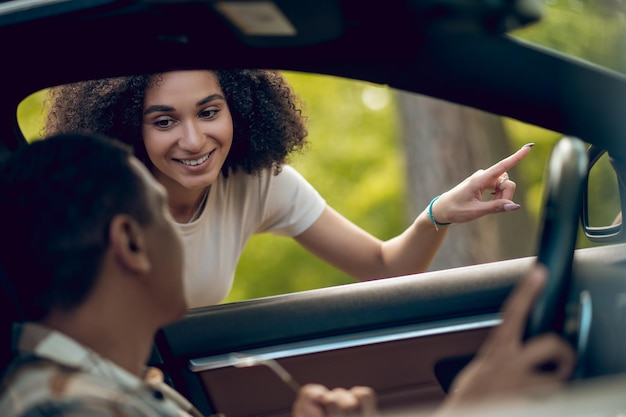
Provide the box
[43,69,308,176]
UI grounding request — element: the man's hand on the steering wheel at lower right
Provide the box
[436,265,575,411]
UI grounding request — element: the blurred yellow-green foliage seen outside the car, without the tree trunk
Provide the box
[18,0,626,302]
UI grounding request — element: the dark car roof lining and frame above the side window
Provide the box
[0,0,626,156]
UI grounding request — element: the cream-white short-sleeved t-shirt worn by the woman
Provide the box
[174,165,326,308]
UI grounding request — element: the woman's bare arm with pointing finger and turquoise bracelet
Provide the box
[295,144,532,280]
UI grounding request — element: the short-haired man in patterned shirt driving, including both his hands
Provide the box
[0,135,574,417]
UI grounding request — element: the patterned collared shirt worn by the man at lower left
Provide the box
[0,323,201,417]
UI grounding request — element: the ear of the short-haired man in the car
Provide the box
[109,214,152,274]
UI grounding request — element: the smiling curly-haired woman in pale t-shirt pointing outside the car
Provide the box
[44,70,530,307]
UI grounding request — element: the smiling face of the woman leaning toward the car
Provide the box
[142,71,233,196]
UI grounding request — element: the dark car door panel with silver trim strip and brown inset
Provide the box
[155,245,626,417]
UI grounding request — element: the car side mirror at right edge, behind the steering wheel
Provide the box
[581,146,626,243]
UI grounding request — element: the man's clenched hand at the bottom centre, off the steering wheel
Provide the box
[292,384,378,417]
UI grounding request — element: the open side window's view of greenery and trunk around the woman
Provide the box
[17,71,572,302]
